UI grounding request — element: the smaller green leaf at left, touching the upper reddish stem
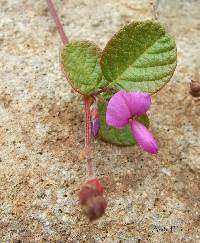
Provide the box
[61,41,108,95]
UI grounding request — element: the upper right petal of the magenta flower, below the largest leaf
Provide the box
[124,92,151,116]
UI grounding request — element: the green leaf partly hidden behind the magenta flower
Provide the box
[98,95,149,146]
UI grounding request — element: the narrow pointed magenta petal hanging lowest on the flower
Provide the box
[131,120,158,154]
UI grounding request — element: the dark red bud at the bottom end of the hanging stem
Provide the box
[79,179,107,220]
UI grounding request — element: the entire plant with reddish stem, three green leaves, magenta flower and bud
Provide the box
[47,0,177,220]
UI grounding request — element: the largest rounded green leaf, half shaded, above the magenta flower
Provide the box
[101,21,177,93]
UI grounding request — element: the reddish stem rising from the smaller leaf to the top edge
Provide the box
[47,0,69,45]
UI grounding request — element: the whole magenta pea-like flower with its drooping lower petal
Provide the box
[106,90,158,154]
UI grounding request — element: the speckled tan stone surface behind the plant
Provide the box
[0,0,200,243]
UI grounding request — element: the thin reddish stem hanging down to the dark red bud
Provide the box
[84,96,94,176]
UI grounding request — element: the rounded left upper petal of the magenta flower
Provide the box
[106,90,132,128]
